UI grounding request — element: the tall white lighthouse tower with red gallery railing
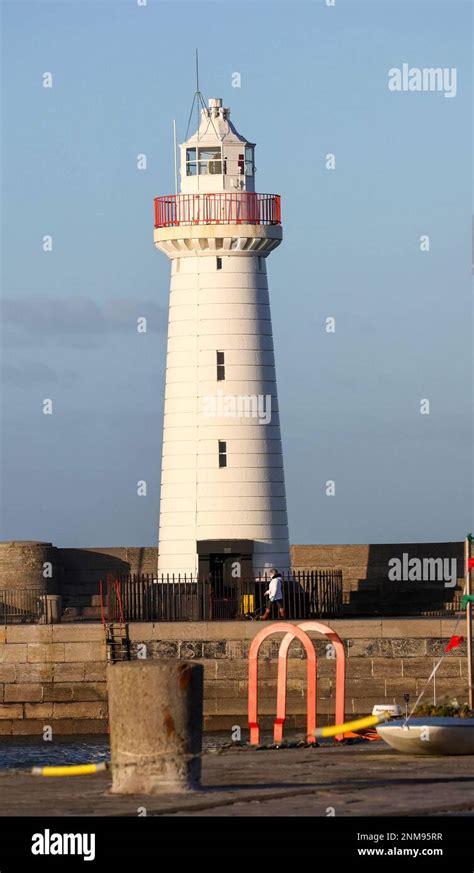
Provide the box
[154,98,290,580]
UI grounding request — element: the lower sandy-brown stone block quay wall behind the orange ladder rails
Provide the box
[0,618,467,736]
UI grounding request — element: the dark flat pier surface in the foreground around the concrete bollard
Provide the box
[0,742,474,816]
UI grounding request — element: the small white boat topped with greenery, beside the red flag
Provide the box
[377,716,474,755]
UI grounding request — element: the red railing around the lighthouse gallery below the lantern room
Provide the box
[155,191,281,227]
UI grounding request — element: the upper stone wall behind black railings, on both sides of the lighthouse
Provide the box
[0,542,464,621]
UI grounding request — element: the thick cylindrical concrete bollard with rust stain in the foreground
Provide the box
[107,659,204,794]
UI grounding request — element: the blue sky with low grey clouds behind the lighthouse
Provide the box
[0,0,473,546]
